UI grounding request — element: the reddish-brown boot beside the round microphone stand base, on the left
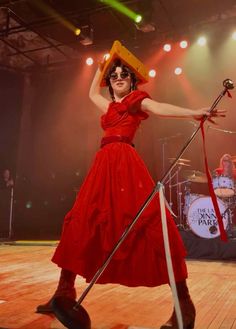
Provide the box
[36,269,76,314]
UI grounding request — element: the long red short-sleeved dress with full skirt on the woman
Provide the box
[52,90,187,287]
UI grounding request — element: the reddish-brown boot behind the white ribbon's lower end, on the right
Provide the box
[160,280,196,329]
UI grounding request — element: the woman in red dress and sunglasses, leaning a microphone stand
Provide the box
[37,60,225,328]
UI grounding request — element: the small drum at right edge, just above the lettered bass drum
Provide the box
[212,175,235,198]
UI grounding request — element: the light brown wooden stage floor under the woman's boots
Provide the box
[0,244,236,329]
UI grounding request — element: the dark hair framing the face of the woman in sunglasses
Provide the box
[105,59,138,101]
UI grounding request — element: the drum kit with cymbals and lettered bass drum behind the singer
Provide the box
[167,157,236,239]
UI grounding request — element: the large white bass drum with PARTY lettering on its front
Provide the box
[187,197,228,239]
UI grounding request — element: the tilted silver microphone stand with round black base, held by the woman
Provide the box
[52,79,234,329]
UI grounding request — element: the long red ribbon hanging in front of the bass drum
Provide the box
[200,120,228,242]
